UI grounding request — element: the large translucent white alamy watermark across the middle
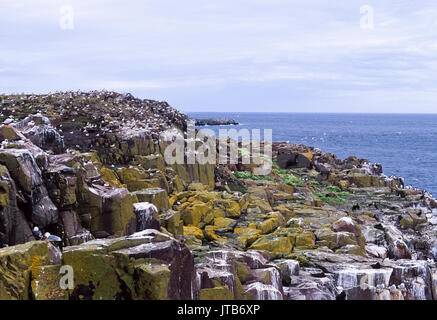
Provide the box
[160,121,272,175]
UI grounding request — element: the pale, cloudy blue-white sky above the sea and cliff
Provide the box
[0,0,437,113]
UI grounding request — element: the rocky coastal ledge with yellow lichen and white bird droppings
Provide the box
[0,92,437,300]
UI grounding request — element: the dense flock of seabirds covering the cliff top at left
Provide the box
[0,90,188,134]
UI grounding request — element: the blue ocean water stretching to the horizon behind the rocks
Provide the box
[188,112,437,196]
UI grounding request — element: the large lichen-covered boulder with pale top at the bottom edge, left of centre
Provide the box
[62,230,194,300]
